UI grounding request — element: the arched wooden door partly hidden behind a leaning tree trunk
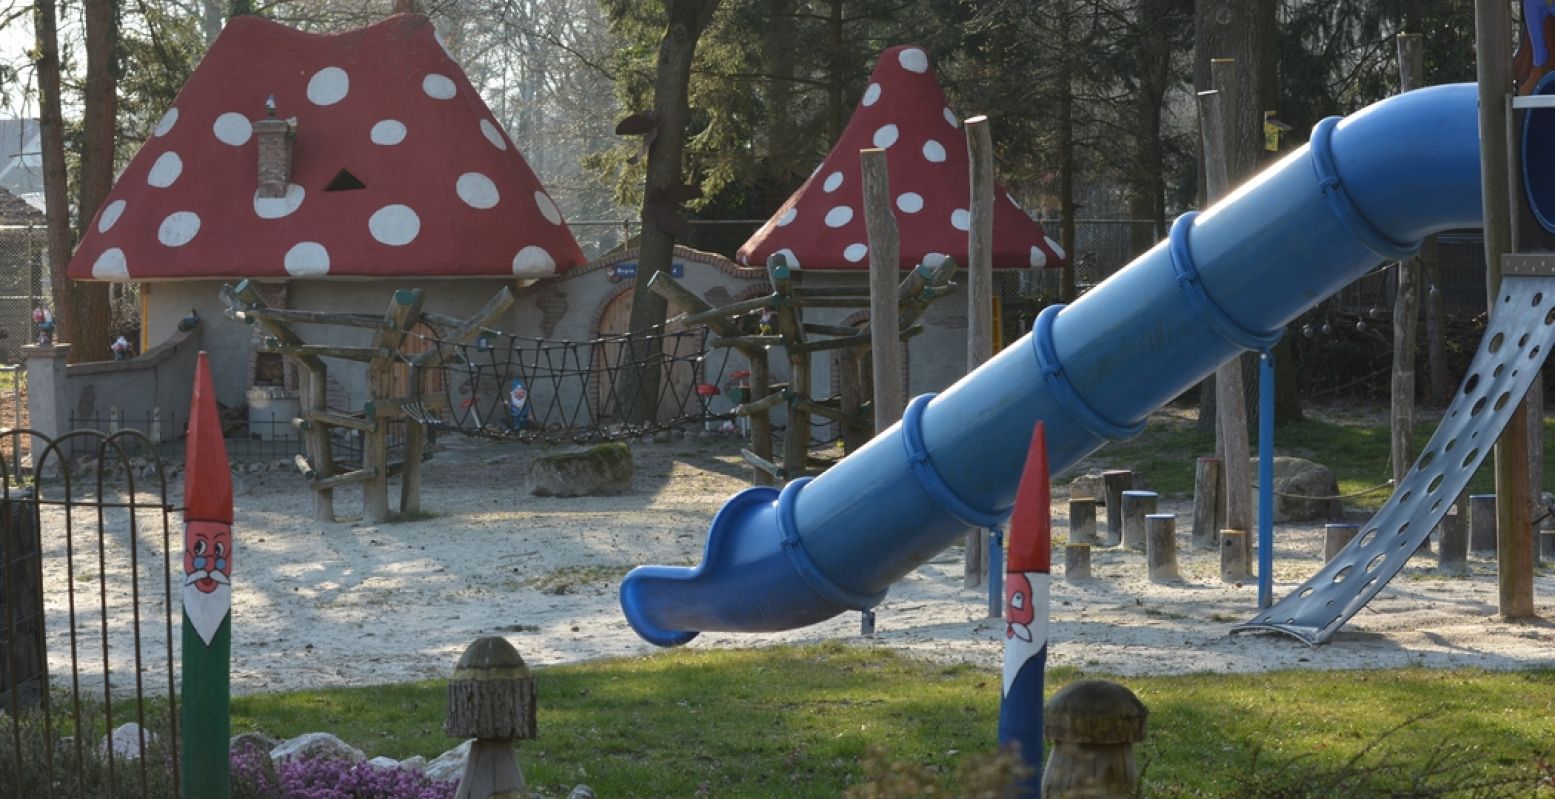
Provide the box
[591,289,701,424]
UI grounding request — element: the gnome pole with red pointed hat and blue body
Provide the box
[998,421,1053,797]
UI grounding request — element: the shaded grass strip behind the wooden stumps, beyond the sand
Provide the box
[1090,406,1555,510]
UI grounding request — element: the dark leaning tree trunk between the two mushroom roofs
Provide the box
[622,0,718,423]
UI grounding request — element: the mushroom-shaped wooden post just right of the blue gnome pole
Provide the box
[1042,679,1149,799]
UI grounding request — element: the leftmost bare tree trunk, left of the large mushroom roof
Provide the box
[33,0,72,351]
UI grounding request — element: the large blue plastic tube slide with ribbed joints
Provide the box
[620,84,1480,647]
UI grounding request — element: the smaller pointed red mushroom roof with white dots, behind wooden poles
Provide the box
[739,45,1064,269]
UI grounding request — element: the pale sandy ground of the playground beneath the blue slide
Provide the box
[30,416,1555,693]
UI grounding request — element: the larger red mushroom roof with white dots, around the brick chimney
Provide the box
[70,14,583,280]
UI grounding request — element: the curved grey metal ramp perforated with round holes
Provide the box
[1232,274,1555,644]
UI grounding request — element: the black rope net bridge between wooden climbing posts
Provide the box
[409,325,748,441]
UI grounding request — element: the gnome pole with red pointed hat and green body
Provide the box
[179,353,232,799]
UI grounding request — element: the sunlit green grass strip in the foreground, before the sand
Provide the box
[233,644,1555,797]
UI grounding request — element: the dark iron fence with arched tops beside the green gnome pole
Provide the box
[0,429,183,799]
